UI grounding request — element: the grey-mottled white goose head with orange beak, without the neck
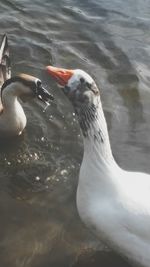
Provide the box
[46,66,99,110]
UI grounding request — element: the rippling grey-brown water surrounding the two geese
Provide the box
[0,0,150,267]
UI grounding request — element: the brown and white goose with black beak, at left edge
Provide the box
[0,35,53,138]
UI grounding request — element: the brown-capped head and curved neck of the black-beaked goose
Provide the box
[1,74,54,102]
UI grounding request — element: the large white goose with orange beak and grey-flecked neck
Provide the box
[47,66,150,267]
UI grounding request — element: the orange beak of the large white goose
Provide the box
[46,66,74,86]
